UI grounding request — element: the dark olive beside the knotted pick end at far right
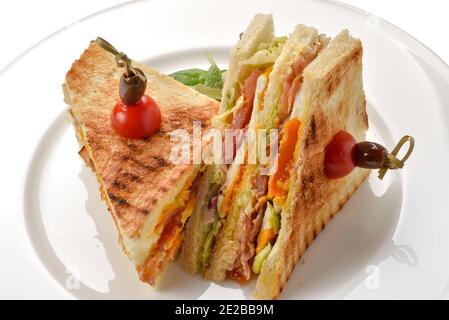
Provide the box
[355,141,388,169]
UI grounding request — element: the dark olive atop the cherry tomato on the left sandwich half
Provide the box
[119,68,147,105]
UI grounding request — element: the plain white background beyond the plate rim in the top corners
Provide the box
[0,0,449,72]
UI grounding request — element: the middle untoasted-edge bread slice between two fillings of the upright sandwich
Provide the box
[206,25,319,281]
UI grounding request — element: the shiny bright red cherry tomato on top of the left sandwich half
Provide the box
[111,95,162,139]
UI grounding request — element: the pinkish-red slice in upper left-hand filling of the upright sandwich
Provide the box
[231,69,261,129]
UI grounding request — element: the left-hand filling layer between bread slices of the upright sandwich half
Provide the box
[200,37,287,271]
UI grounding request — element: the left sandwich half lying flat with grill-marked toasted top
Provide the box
[63,42,219,285]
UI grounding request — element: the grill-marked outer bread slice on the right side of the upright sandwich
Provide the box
[254,30,369,299]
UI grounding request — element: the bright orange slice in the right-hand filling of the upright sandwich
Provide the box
[268,118,301,197]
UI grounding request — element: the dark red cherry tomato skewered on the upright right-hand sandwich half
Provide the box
[324,131,356,179]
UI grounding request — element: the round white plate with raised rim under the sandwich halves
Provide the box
[0,0,449,299]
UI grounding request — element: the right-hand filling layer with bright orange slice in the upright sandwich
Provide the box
[228,34,324,282]
